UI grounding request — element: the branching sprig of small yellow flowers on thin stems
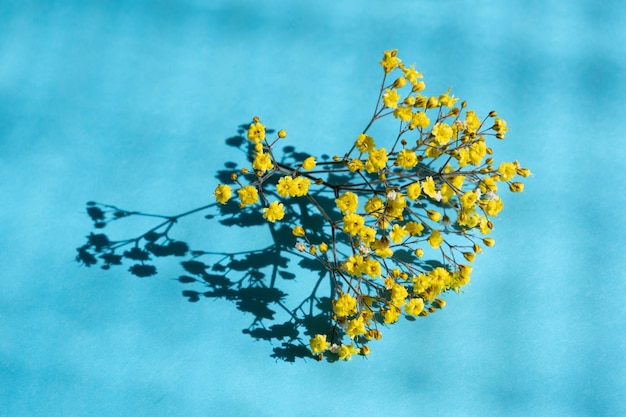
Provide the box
[214,50,530,360]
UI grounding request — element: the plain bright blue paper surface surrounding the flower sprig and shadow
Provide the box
[0,0,626,416]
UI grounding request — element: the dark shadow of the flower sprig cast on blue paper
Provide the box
[76,125,346,362]
